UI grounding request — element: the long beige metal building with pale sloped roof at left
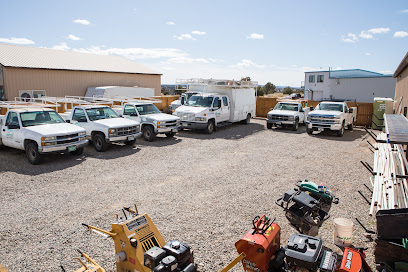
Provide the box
[0,43,161,100]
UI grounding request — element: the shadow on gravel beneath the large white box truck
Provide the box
[177,123,265,140]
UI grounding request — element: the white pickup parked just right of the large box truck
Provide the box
[266,102,310,131]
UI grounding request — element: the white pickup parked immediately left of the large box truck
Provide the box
[114,102,180,142]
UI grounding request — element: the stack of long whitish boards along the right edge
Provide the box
[370,133,408,215]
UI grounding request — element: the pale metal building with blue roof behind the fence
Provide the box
[304,69,396,103]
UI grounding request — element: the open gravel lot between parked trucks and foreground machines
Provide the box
[0,119,375,271]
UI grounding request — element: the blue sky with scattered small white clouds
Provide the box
[0,0,408,86]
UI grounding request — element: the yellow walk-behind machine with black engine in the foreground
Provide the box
[69,205,197,272]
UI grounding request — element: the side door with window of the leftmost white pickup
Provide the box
[1,112,23,148]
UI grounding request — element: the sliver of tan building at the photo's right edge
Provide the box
[394,53,408,117]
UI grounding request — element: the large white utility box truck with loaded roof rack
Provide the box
[174,78,257,134]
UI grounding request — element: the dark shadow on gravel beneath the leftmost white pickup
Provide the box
[0,146,87,176]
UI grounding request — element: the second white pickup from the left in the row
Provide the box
[61,105,141,152]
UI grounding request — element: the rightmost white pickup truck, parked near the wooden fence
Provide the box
[306,102,357,137]
